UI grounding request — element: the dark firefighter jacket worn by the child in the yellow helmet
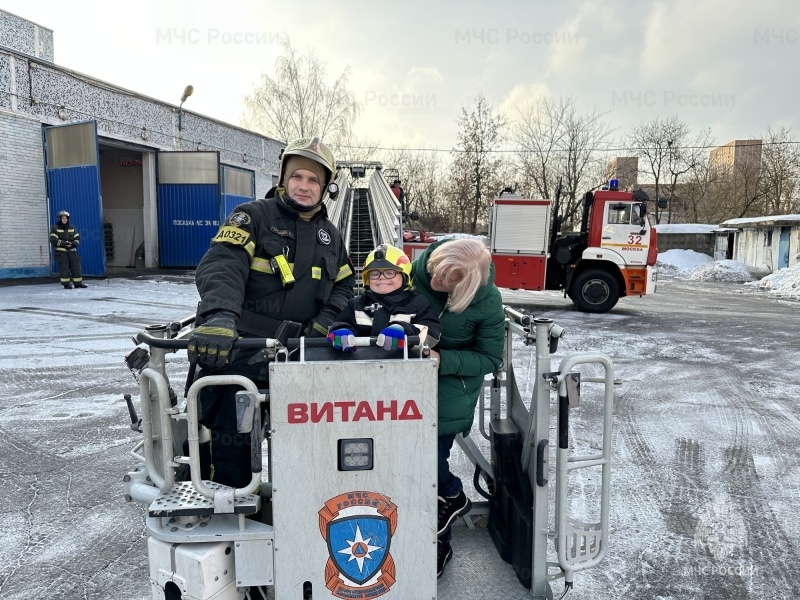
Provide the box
[331,289,442,348]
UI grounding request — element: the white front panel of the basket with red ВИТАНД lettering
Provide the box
[270,360,438,600]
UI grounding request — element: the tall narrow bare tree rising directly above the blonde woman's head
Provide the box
[448,94,507,233]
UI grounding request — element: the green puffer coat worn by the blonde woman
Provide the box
[413,240,505,435]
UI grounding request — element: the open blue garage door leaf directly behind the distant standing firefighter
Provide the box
[44,121,106,277]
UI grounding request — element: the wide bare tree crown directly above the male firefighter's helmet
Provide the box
[242,35,361,142]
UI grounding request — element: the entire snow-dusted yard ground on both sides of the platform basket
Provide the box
[0,258,800,600]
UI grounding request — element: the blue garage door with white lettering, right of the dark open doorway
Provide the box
[157,152,220,268]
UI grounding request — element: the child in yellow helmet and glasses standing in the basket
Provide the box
[328,244,442,352]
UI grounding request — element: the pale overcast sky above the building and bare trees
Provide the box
[0,0,800,155]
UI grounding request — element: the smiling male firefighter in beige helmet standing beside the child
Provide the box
[189,138,355,487]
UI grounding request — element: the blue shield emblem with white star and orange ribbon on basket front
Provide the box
[319,491,397,598]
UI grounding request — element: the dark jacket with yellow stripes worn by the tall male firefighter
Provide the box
[196,198,354,337]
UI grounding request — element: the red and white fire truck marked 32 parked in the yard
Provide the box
[403,179,664,313]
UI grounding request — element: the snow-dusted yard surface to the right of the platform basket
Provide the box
[506,258,800,600]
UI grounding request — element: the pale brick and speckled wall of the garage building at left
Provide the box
[0,9,285,279]
